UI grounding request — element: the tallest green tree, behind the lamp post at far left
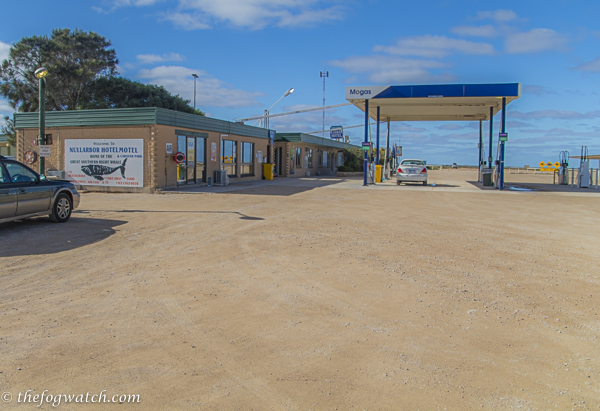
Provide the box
[0,29,118,112]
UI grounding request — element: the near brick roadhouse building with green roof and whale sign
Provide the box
[14,107,275,193]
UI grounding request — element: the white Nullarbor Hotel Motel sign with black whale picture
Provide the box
[65,140,144,187]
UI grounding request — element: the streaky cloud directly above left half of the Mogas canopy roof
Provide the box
[330,56,453,84]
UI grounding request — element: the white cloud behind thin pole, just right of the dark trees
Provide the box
[137,66,262,110]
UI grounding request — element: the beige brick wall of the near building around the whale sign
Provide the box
[16,125,268,193]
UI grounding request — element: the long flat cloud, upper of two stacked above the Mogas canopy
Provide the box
[374,35,495,58]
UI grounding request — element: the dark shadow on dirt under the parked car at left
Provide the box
[0,213,127,258]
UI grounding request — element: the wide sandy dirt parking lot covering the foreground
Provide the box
[0,170,600,410]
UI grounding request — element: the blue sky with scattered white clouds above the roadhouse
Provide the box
[0,0,600,166]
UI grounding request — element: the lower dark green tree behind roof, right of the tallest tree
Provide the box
[81,77,204,116]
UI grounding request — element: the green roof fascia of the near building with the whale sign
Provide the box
[14,107,269,139]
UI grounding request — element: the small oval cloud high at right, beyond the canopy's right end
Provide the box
[504,29,567,54]
